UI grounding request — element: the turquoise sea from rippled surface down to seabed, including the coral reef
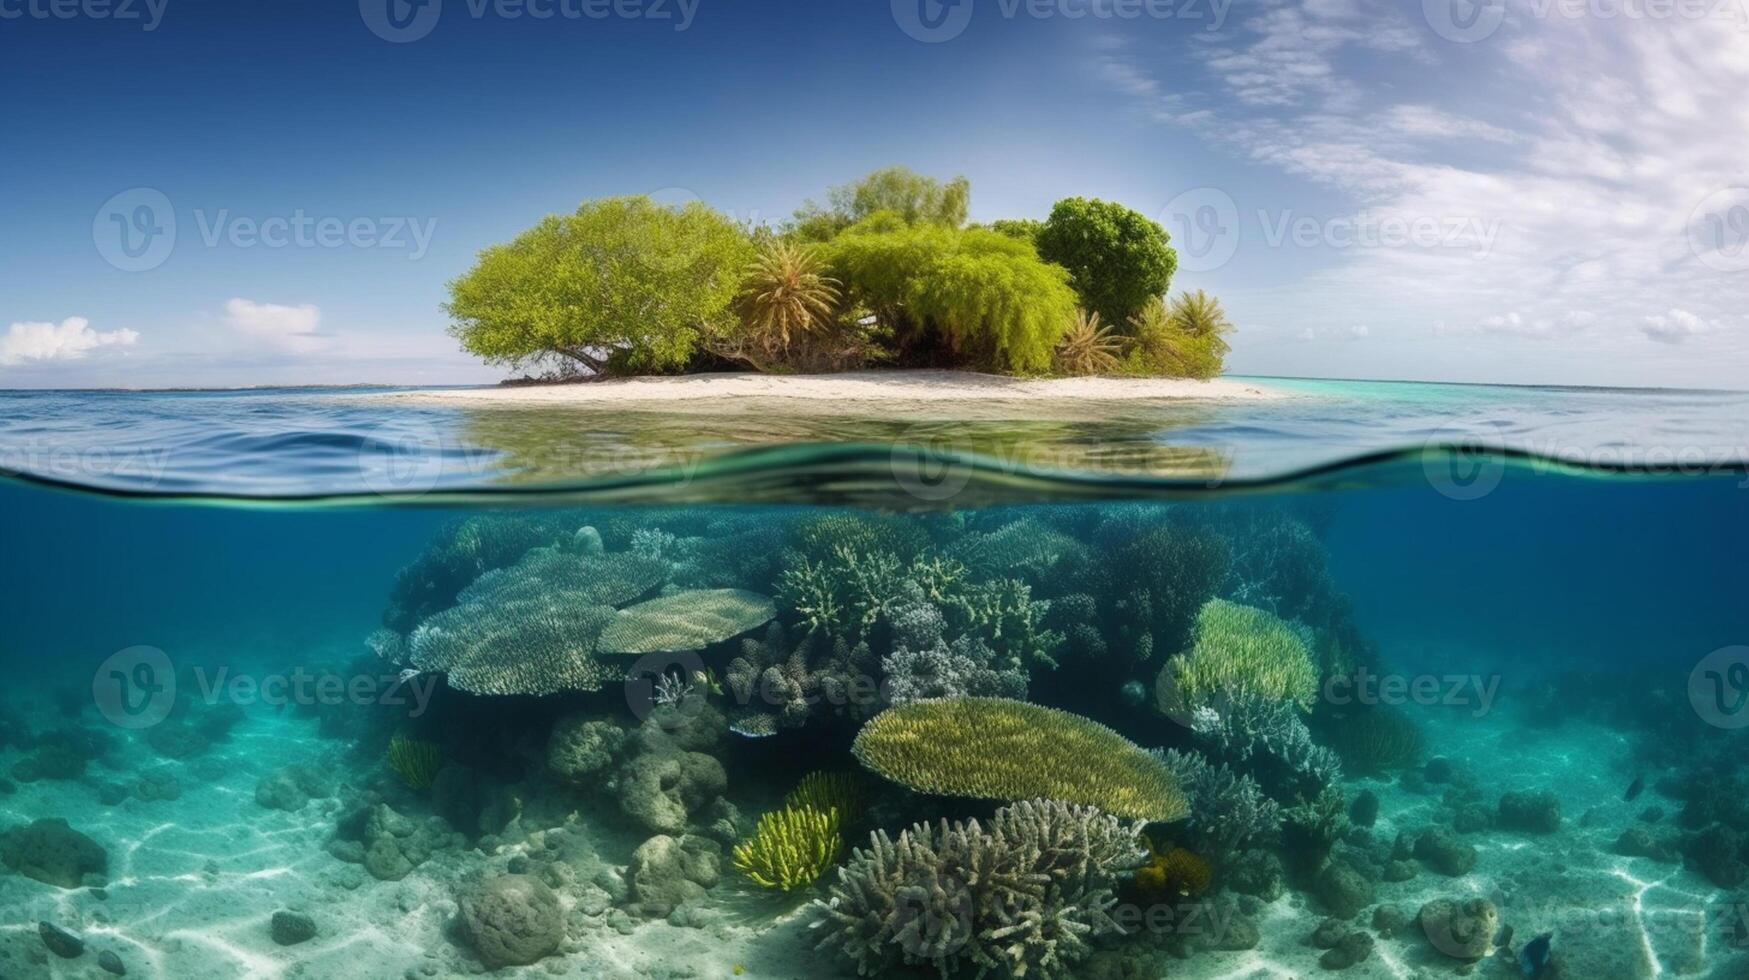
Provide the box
[0,380,1749,978]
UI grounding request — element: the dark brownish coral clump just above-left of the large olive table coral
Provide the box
[724,623,880,737]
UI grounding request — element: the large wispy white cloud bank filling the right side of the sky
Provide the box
[1100,0,1749,383]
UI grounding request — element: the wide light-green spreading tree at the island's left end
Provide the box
[444,196,754,375]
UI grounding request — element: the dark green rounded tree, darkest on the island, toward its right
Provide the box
[1037,198,1179,324]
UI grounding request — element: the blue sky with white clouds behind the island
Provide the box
[0,0,1749,387]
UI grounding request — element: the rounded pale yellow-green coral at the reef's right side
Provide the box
[1154,599,1317,718]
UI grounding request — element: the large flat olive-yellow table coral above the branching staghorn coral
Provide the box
[852,698,1188,821]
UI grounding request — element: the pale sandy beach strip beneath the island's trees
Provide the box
[379,371,1293,413]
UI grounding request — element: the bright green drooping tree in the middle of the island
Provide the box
[826,214,1076,373]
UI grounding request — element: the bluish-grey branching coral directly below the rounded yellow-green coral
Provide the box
[1191,695,1341,800]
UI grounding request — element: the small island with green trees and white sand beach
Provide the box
[444,166,1266,404]
